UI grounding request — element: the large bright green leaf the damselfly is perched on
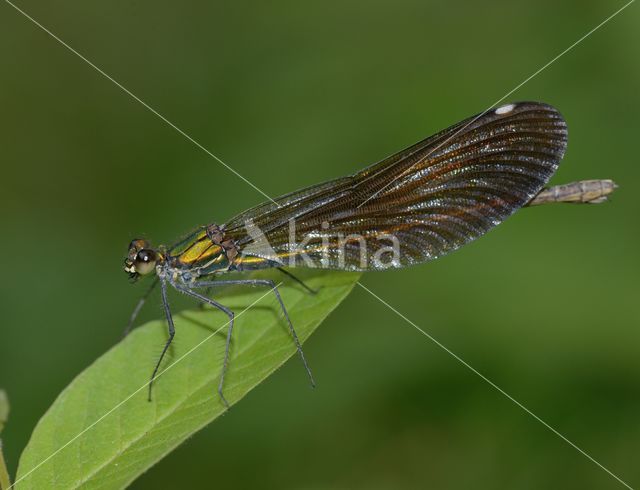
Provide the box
[16,271,359,490]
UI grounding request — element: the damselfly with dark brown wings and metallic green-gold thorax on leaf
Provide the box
[124,102,606,405]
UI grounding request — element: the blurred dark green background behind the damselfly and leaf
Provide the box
[0,0,640,489]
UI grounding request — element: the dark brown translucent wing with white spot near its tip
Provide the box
[225,102,567,270]
